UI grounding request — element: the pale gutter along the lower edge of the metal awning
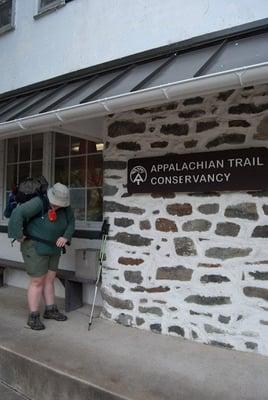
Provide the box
[0,62,268,139]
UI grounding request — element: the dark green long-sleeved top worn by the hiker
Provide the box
[8,197,75,255]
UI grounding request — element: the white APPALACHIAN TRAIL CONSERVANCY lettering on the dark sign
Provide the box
[150,156,264,185]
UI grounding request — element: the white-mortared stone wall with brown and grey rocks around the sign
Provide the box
[102,85,268,354]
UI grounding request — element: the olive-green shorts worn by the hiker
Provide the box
[20,240,60,277]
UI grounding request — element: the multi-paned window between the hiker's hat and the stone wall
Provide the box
[54,133,103,223]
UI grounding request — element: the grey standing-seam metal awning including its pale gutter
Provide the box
[0,27,268,136]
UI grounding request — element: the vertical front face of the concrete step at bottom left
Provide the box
[0,346,126,400]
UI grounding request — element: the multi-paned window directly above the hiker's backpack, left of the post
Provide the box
[5,133,43,206]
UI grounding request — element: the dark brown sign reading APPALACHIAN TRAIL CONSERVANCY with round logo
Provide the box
[127,147,268,193]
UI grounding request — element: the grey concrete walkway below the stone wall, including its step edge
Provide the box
[0,287,268,400]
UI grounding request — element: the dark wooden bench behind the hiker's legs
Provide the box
[0,258,96,312]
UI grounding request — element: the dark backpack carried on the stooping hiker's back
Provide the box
[4,175,48,218]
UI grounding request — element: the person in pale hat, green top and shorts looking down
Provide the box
[8,183,74,330]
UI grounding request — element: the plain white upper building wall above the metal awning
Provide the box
[0,0,268,93]
